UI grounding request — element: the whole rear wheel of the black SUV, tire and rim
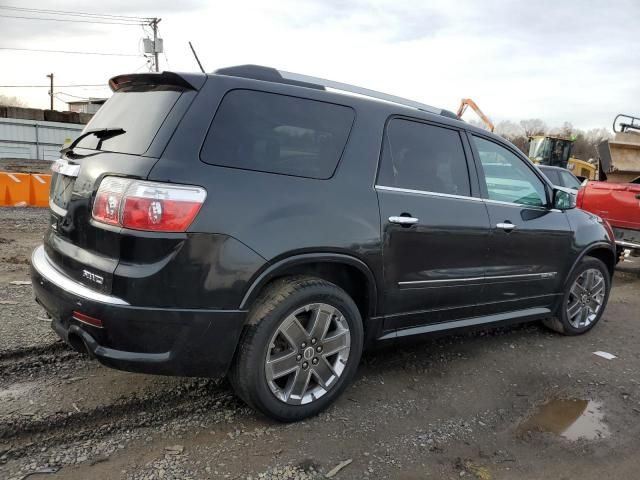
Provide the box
[229,277,363,422]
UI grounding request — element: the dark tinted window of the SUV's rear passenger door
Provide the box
[378,119,471,195]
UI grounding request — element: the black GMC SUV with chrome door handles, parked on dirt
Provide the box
[31,66,615,421]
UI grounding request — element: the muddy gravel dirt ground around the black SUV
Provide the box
[0,209,640,480]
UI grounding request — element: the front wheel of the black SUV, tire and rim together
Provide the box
[542,257,611,335]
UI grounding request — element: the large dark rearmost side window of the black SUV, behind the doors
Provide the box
[200,90,354,179]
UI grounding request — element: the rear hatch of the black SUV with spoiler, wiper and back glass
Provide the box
[45,72,206,293]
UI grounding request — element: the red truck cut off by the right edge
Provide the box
[576,182,640,256]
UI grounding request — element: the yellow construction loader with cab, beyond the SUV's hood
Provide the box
[529,135,598,180]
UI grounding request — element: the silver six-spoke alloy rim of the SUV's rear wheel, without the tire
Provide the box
[265,303,351,405]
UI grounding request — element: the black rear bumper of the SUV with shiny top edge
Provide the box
[31,246,246,377]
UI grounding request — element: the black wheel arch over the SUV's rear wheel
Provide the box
[240,253,378,320]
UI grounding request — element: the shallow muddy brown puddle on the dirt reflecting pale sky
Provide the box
[520,399,611,440]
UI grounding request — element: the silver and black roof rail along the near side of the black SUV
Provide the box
[214,65,444,119]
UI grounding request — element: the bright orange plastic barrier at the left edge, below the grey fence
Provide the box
[0,172,51,207]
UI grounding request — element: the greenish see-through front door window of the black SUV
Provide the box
[473,136,547,206]
